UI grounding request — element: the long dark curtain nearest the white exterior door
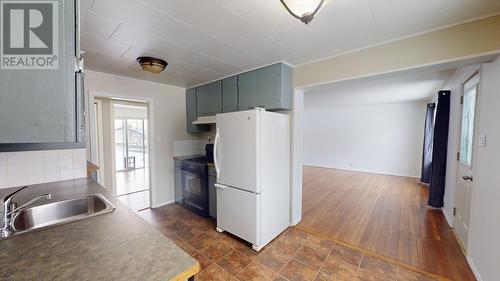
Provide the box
[428,91,451,208]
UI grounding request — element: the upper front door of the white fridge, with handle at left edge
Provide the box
[214,110,260,193]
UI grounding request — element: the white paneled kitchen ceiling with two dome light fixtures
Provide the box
[81,0,500,87]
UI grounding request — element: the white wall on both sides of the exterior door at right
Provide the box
[443,55,500,281]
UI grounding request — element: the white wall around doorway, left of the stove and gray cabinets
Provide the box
[85,71,198,207]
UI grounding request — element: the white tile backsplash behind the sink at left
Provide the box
[0,149,87,188]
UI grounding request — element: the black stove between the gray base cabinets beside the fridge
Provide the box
[181,144,213,217]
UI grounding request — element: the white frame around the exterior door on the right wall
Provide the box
[453,65,481,249]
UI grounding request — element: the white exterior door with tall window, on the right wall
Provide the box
[454,73,479,249]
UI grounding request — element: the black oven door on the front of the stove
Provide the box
[181,168,208,216]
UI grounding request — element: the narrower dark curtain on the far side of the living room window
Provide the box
[420,103,436,183]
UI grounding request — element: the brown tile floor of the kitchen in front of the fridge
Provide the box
[139,204,440,281]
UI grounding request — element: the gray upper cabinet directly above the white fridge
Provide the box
[238,63,293,110]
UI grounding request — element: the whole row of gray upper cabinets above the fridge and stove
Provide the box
[186,63,293,133]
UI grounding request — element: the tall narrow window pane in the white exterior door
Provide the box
[460,75,479,167]
